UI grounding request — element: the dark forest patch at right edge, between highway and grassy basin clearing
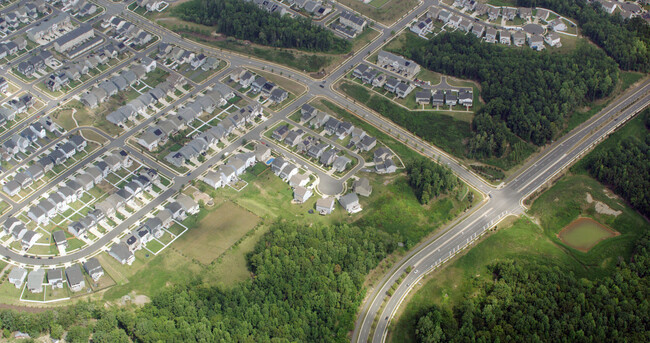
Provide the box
[585,109,650,217]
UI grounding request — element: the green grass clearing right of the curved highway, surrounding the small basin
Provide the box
[389,175,650,343]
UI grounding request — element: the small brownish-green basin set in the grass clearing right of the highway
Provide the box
[558,218,618,252]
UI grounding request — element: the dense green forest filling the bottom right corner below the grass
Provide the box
[416,233,650,343]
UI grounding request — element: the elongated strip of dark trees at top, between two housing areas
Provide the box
[174,0,351,53]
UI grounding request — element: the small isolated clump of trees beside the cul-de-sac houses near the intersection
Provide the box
[406,158,458,205]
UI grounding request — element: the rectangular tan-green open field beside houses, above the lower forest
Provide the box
[173,202,259,264]
